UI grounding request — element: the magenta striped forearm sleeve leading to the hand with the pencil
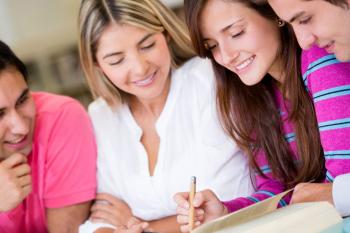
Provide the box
[223,152,290,212]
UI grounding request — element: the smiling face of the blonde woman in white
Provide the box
[96,24,171,101]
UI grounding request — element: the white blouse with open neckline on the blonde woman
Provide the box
[80,58,253,232]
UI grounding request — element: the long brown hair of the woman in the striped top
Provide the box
[184,0,325,187]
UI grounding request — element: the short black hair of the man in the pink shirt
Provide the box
[0,41,28,82]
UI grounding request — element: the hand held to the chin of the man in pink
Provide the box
[0,153,32,212]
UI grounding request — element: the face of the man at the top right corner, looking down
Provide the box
[269,0,350,61]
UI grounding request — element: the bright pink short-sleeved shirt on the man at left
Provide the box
[0,93,96,233]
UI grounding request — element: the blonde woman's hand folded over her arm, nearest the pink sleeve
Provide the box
[91,193,133,227]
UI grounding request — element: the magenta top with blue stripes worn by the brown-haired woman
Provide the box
[224,47,350,212]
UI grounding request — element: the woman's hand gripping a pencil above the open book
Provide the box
[174,190,228,232]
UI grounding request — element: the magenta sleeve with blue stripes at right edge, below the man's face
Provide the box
[302,47,350,182]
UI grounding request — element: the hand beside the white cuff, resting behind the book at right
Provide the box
[290,183,334,205]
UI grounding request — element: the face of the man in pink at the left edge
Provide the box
[0,68,35,161]
